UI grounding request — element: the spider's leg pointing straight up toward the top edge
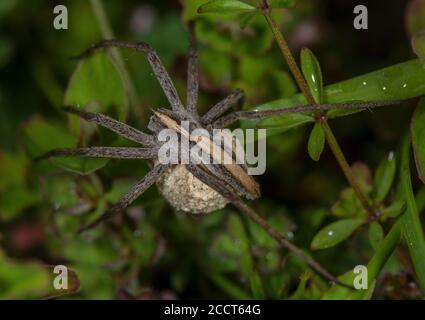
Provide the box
[187,24,199,114]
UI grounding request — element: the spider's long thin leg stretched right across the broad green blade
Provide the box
[212,100,401,128]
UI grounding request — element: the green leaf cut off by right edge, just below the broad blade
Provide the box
[410,98,425,183]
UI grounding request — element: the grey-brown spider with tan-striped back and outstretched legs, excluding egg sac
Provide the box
[38,29,397,285]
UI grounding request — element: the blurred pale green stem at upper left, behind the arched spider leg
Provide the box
[90,0,146,119]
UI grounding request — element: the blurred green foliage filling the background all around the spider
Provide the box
[0,0,425,299]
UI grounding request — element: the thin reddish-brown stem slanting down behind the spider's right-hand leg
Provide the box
[261,0,375,216]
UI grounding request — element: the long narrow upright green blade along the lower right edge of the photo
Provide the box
[400,137,425,292]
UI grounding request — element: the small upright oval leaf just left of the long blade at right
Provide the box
[373,152,397,203]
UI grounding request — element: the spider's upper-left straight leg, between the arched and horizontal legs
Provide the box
[63,107,154,146]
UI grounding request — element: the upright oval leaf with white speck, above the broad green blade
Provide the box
[301,48,323,103]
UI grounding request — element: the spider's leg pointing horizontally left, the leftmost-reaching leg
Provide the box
[36,147,157,160]
